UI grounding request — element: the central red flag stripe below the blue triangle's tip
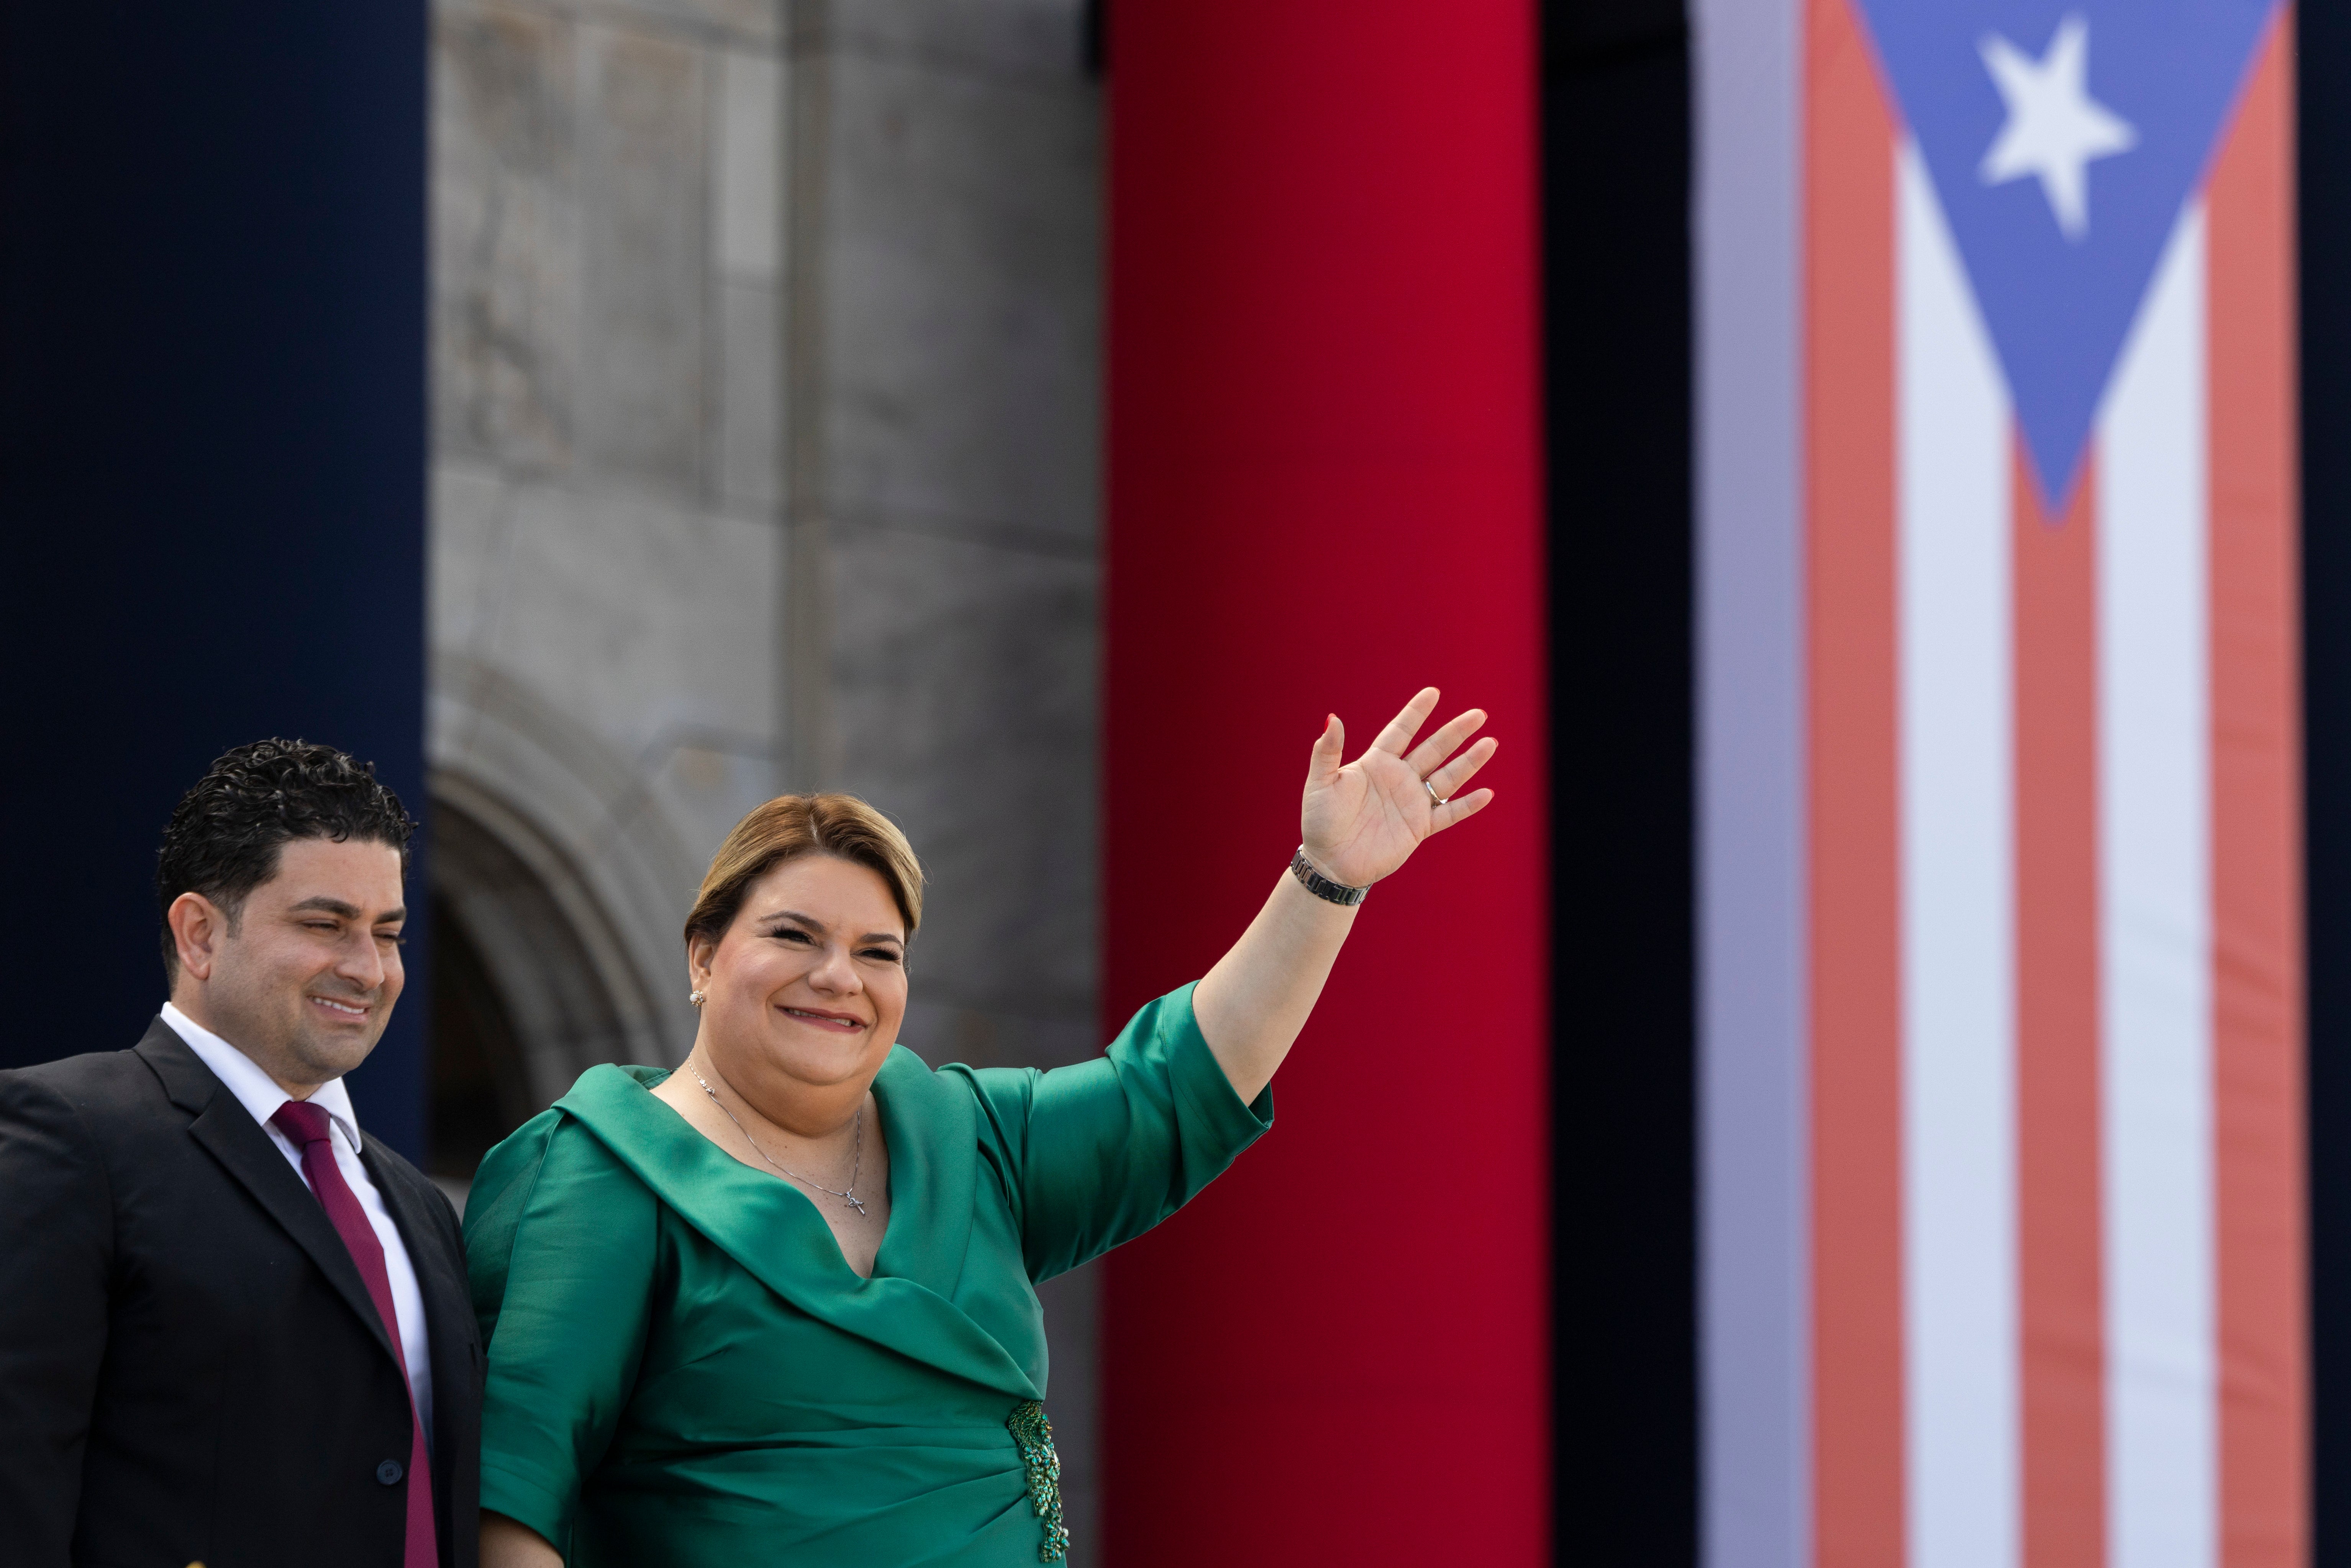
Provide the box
[2010,442,2107,1568]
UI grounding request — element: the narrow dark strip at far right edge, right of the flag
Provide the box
[2295,5,2351,1566]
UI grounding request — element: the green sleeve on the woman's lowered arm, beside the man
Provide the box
[466,1112,661,1554]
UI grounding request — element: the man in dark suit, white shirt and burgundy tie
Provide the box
[0,741,482,1568]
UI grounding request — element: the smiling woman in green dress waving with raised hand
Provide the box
[466,689,1495,1568]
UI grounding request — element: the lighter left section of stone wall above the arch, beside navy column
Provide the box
[428,0,788,1060]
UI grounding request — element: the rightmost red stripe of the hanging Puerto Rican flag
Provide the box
[2205,10,2311,1568]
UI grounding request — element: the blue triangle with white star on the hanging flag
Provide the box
[1857,0,2278,515]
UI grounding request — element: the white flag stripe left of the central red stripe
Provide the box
[1895,141,2020,1568]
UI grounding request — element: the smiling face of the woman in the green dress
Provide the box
[687,854,905,1124]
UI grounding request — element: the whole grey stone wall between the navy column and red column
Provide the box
[428,0,1100,1561]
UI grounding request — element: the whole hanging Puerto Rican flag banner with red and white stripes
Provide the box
[1697,0,2309,1568]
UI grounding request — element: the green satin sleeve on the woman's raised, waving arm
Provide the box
[964,985,1274,1279]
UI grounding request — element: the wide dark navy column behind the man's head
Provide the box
[0,0,426,1154]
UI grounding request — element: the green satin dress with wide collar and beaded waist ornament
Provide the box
[466,985,1274,1568]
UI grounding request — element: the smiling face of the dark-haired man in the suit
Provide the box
[169,839,407,1098]
